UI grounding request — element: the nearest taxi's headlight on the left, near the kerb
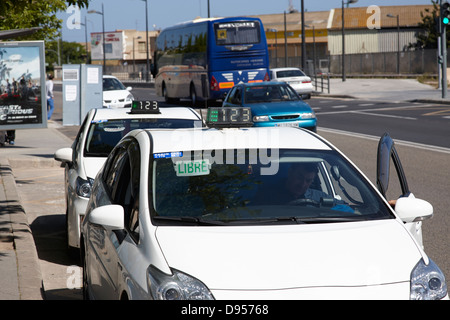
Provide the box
[147,265,214,300]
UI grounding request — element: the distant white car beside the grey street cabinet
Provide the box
[103,75,134,108]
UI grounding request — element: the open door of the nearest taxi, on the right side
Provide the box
[377,133,423,246]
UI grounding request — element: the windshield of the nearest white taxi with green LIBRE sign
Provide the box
[150,149,392,225]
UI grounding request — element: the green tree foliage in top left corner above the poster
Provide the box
[0,0,89,40]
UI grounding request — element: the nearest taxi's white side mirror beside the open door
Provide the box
[395,193,433,223]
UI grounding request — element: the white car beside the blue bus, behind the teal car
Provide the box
[270,68,314,99]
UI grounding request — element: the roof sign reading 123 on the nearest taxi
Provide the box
[206,107,253,128]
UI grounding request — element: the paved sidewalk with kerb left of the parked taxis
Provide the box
[0,122,71,300]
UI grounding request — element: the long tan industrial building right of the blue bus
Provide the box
[253,5,437,74]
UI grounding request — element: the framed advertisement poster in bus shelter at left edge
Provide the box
[0,41,47,130]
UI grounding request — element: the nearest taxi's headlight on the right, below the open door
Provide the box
[410,259,447,300]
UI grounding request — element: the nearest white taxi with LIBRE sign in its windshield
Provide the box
[82,113,448,300]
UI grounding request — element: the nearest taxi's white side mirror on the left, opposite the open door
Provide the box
[88,204,125,230]
